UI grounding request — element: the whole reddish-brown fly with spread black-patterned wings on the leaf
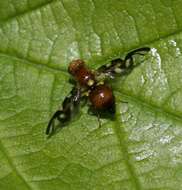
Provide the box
[46,47,150,135]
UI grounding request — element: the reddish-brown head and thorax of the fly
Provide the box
[68,59,95,86]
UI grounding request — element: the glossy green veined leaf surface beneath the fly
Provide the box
[0,0,182,190]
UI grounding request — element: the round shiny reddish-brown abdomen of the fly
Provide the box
[89,85,115,111]
